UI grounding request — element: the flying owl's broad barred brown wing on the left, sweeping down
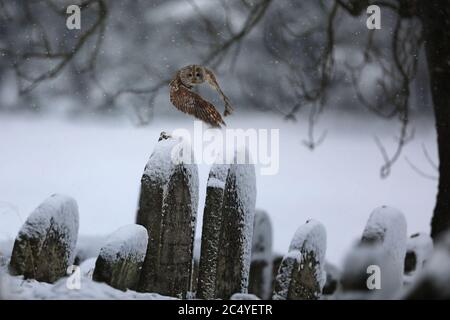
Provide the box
[170,86,225,128]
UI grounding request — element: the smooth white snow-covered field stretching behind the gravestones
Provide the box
[0,113,436,266]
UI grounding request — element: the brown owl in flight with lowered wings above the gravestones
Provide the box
[169,64,233,128]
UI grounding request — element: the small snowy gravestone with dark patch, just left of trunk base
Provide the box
[404,233,433,283]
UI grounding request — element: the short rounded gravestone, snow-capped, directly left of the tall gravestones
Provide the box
[92,224,148,291]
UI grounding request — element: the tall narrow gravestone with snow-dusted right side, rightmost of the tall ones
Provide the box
[215,149,256,299]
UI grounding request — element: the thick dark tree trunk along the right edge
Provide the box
[420,0,450,240]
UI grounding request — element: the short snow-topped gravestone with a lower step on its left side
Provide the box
[273,220,327,300]
